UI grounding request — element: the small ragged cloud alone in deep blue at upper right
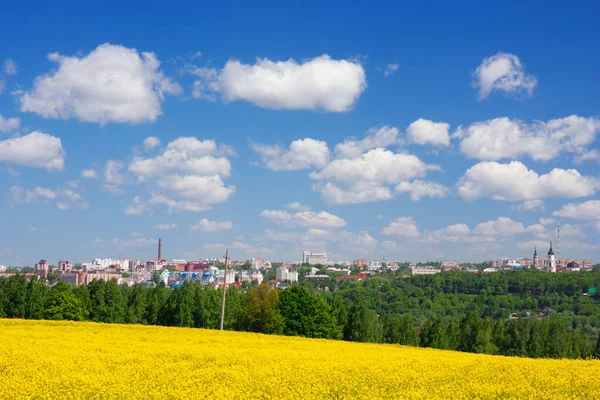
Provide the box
[473,52,537,100]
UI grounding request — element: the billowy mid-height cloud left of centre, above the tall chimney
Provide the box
[128,137,235,211]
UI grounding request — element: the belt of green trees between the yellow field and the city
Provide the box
[0,270,600,358]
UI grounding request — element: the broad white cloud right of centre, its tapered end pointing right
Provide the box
[310,148,439,204]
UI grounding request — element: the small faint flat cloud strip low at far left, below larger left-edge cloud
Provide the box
[10,185,88,210]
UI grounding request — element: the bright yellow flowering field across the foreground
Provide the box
[0,319,600,399]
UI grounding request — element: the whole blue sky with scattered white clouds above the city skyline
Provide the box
[0,1,600,265]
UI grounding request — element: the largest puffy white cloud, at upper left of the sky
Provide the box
[19,43,181,124]
